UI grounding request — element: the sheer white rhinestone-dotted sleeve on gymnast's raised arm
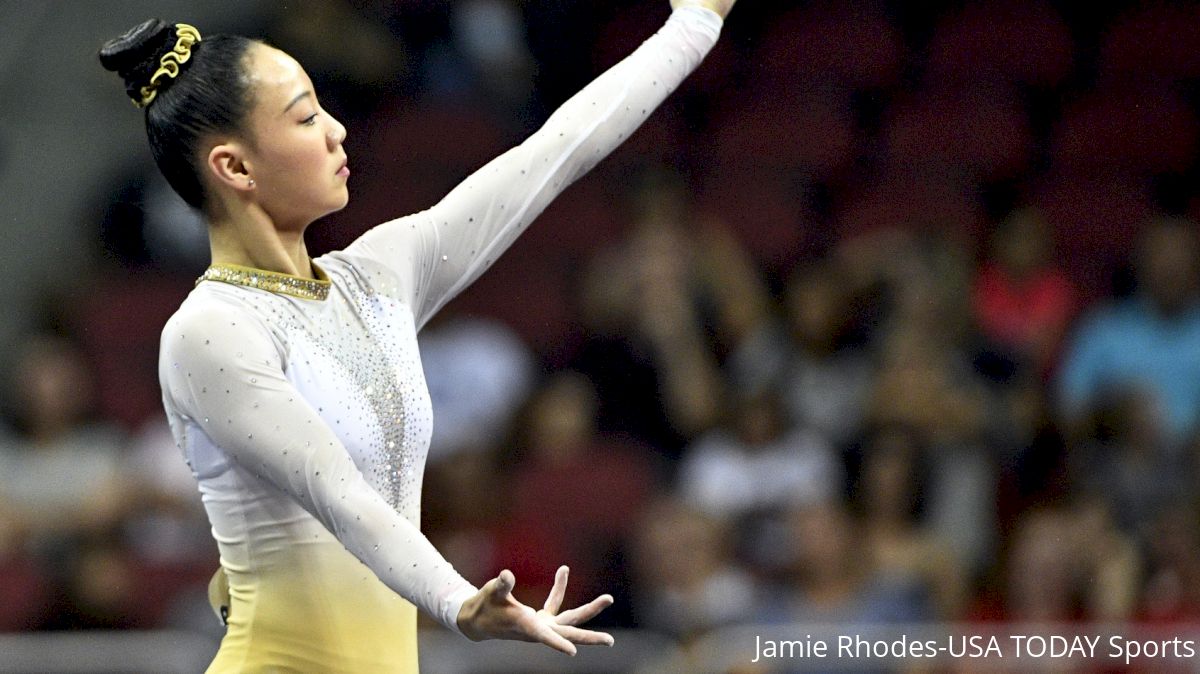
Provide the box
[338,7,721,327]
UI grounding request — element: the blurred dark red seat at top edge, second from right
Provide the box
[929,0,1073,86]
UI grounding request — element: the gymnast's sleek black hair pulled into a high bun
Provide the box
[100,19,254,209]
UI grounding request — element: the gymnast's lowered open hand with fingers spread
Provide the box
[458,566,613,655]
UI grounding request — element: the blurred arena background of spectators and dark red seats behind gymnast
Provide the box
[0,0,1200,674]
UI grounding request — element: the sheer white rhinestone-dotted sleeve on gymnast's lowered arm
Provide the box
[161,302,476,632]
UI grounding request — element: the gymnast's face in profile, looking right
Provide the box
[235,44,349,229]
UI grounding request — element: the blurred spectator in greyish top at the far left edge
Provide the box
[0,333,136,628]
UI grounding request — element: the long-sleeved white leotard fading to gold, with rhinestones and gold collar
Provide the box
[160,8,721,673]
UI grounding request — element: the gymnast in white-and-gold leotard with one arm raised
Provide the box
[100,0,736,672]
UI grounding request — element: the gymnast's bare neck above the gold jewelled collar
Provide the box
[209,207,313,278]
